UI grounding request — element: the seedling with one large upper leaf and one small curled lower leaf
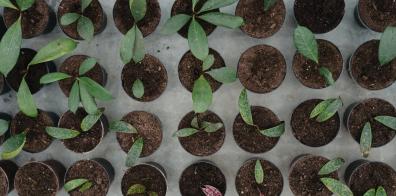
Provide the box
[294,26,335,86]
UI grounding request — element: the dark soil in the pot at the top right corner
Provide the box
[357,0,396,32]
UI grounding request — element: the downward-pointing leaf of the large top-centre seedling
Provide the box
[188,18,209,61]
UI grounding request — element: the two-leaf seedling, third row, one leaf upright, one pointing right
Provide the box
[238,89,285,138]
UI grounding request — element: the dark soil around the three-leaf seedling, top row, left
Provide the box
[58,0,107,40]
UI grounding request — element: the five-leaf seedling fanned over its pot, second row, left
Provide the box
[40,58,114,114]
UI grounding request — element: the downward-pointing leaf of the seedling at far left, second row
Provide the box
[17,78,38,118]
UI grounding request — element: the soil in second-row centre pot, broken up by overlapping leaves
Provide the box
[178,48,226,92]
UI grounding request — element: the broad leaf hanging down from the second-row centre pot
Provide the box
[192,76,213,113]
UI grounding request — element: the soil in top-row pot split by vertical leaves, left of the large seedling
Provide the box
[113,0,161,37]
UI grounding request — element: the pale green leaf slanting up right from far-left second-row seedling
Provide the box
[29,38,78,65]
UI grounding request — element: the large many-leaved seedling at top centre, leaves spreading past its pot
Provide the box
[162,0,243,61]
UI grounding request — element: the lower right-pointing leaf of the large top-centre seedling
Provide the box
[199,12,244,29]
